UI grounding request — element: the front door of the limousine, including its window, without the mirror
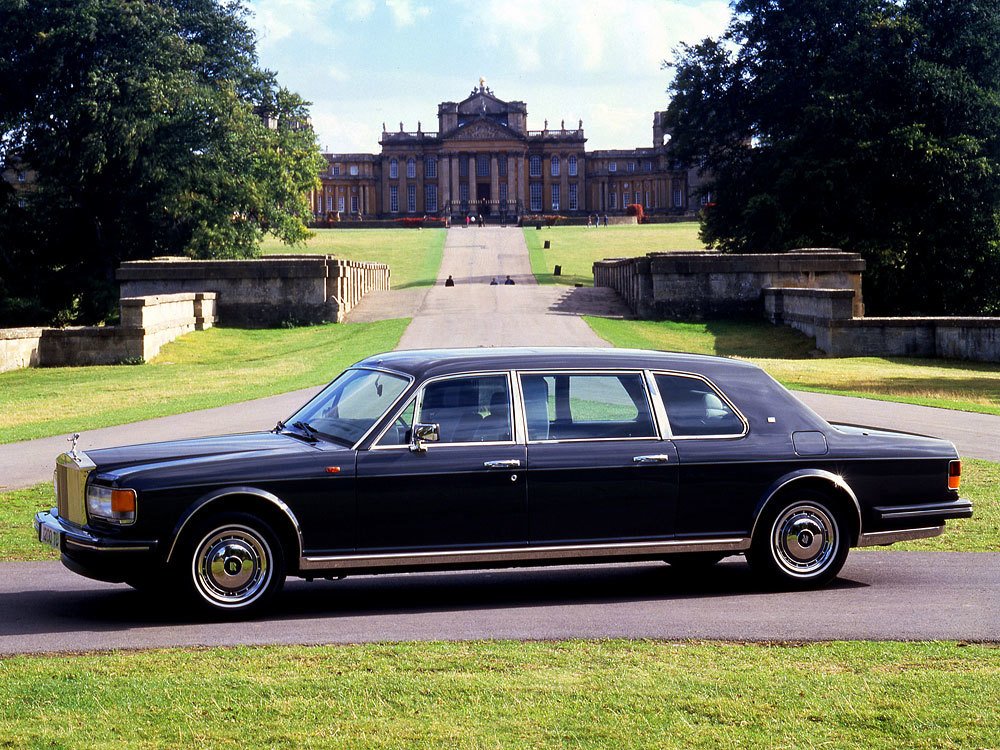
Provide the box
[357,373,527,553]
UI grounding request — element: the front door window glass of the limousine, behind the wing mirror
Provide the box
[419,375,513,443]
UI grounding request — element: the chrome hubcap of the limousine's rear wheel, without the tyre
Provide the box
[771,503,839,576]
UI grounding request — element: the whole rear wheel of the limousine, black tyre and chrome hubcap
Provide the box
[747,495,850,588]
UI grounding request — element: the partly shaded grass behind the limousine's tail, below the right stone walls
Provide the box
[585,317,1000,414]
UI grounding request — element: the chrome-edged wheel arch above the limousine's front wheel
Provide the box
[165,487,303,570]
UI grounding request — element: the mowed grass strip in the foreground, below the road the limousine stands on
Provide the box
[0,640,1000,750]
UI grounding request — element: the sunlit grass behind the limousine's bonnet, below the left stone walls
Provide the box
[0,319,409,443]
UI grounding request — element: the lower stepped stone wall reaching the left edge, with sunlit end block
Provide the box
[0,292,216,371]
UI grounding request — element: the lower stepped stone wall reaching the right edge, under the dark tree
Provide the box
[764,289,1000,362]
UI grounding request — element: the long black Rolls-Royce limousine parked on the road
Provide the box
[35,349,972,616]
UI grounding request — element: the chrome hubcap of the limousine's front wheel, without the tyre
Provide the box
[193,526,271,607]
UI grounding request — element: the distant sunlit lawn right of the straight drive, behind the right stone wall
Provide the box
[524,221,704,286]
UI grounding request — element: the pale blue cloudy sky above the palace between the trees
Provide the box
[247,0,729,153]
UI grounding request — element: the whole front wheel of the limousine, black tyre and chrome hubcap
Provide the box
[178,513,285,618]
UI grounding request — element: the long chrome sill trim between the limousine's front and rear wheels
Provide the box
[299,537,750,570]
